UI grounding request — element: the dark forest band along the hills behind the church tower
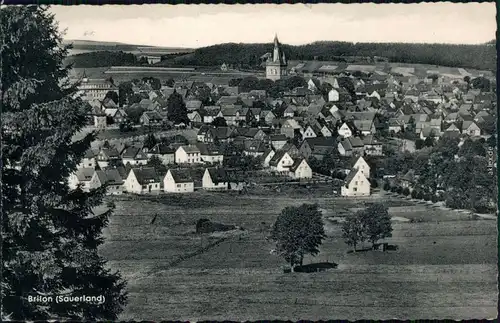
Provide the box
[66,42,496,71]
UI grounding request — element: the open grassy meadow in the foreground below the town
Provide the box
[101,192,498,321]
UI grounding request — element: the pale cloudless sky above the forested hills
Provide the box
[50,2,496,48]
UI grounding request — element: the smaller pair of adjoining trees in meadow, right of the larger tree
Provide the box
[342,203,392,251]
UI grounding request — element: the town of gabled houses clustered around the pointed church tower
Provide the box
[69,37,496,202]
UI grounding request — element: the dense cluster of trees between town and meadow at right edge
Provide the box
[382,137,498,212]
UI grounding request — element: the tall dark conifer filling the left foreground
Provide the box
[0,6,127,321]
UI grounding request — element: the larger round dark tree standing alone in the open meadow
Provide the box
[271,204,326,268]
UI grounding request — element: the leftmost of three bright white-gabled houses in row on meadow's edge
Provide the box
[123,167,161,194]
